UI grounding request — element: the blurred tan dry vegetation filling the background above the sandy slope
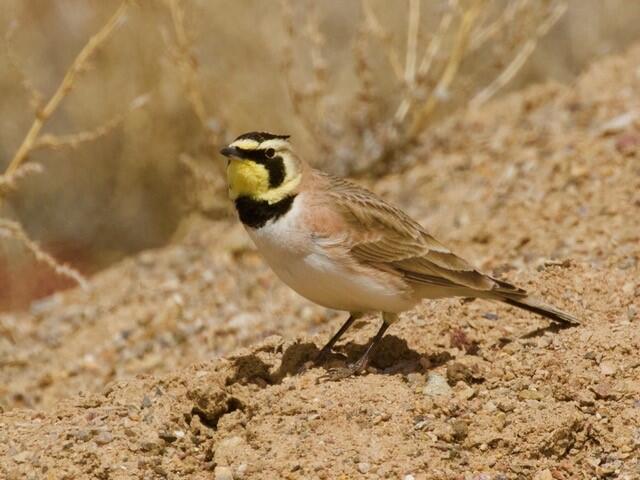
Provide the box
[0,0,640,308]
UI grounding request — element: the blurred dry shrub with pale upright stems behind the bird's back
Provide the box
[282,0,567,174]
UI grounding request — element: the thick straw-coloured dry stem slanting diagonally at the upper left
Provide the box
[6,1,128,175]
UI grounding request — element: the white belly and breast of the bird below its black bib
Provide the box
[247,198,414,312]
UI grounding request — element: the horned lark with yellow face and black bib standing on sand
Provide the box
[220,132,578,374]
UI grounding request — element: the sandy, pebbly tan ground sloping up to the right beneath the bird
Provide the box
[0,47,640,480]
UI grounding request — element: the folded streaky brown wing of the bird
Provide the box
[324,175,524,293]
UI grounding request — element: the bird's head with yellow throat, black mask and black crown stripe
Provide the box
[220,132,302,204]
